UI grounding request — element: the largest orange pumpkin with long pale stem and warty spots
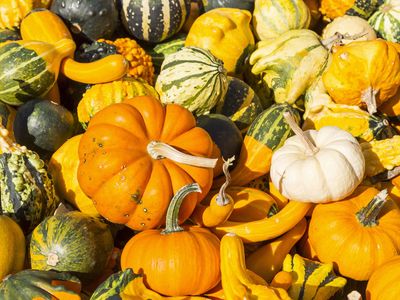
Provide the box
[78,96,216,230]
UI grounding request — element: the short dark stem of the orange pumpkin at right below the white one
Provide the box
[356,189,388,227]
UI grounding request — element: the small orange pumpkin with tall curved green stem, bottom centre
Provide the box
[121,183,221,296]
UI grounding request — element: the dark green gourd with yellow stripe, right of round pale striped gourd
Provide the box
[215,77,263,132]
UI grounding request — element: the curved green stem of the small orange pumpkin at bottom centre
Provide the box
[161,183,201,234]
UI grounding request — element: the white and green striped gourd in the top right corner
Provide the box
[368,0,400,43]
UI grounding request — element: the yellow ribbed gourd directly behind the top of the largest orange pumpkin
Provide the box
[77,78,158,129]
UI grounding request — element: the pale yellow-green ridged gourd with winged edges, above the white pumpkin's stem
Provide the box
[250,29,329,104]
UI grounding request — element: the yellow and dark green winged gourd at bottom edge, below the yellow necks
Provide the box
[283,254,347,300]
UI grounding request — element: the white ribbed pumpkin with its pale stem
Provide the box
[270,115,365,203]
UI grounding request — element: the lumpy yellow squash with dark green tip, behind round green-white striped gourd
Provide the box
[185,8,254,75]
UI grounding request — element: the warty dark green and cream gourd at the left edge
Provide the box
[0,150,59,233]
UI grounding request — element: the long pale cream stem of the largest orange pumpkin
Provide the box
[147,141,218,169]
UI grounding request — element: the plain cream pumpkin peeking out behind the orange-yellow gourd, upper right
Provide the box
[322,15,376,44]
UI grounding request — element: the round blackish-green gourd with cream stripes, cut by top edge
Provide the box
[121,0,190,43]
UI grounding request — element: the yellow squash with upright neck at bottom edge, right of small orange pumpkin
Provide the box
[220,233,291,300]
